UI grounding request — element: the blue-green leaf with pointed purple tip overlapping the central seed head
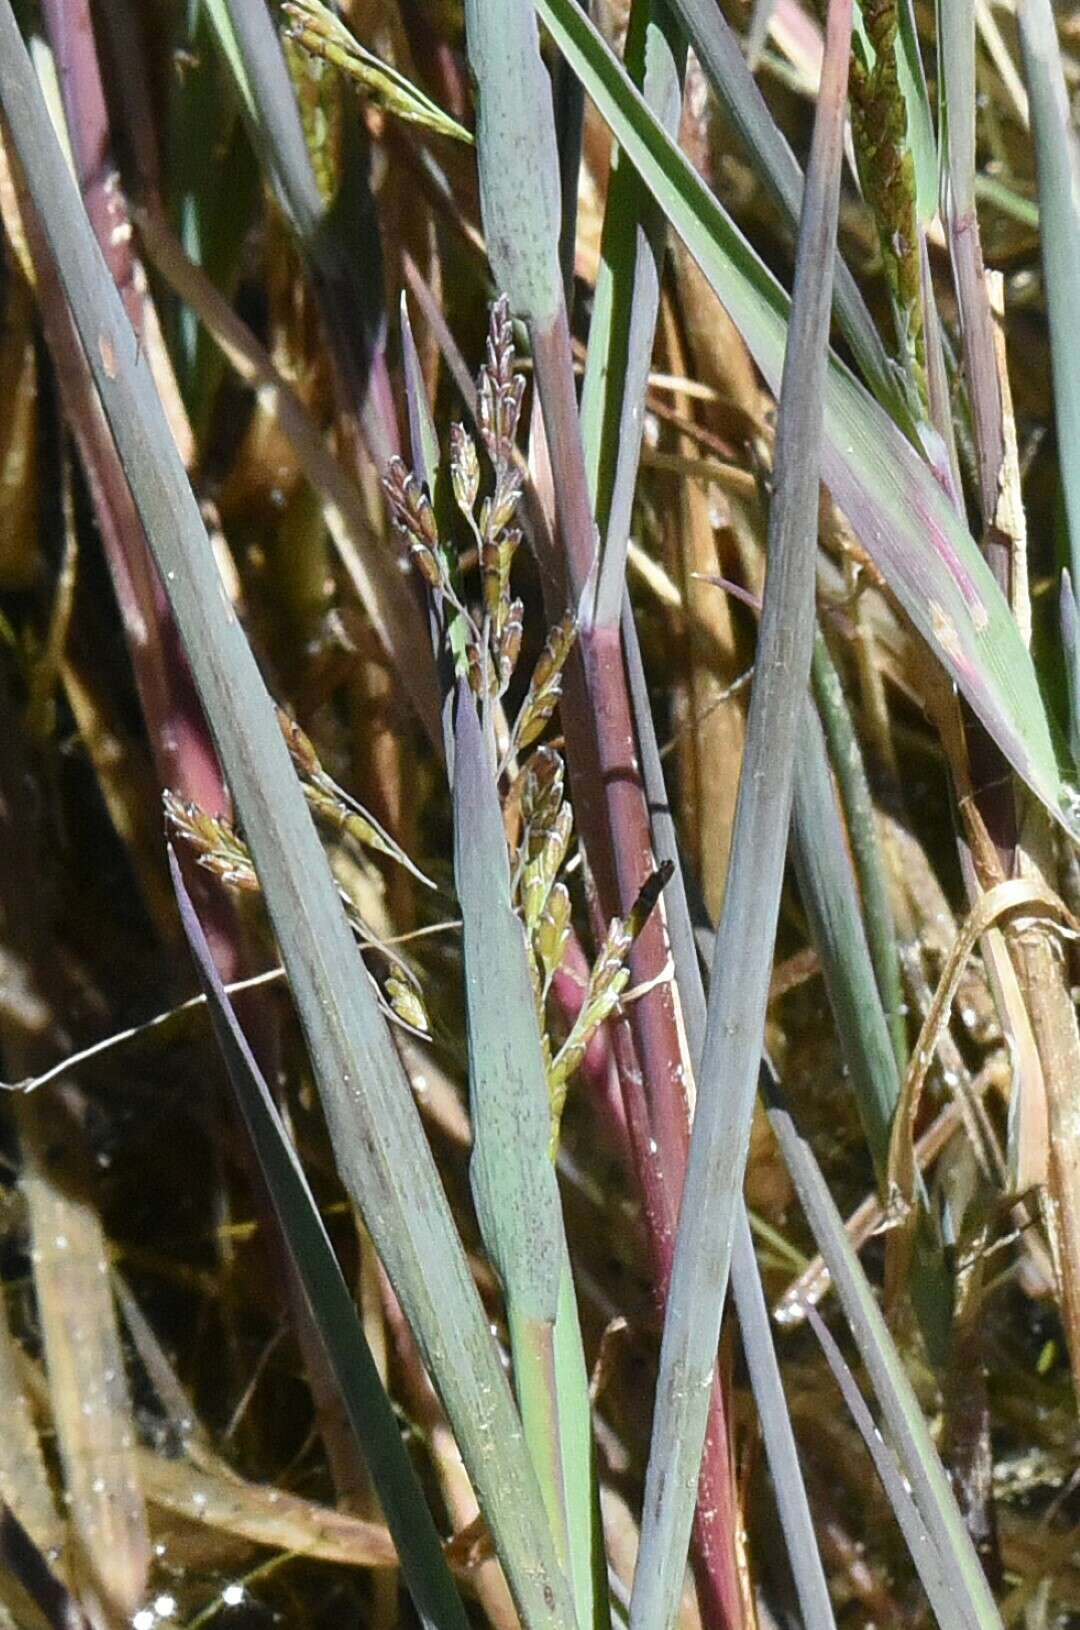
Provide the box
[453,681,606,1630]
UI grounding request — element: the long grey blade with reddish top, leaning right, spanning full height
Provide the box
[630,12,852,1630]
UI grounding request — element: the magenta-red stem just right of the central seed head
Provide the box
[533,313,743,1630]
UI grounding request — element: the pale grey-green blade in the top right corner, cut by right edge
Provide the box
[1016,0,1080,584]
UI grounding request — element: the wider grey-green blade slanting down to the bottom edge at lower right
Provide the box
[761,1071,1002,1630]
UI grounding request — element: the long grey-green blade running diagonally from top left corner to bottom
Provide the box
[0,19,573,1630]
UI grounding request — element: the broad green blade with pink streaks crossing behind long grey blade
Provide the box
[536,0,1080,833]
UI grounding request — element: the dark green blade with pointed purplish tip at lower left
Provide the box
[169,844,468,1630]
